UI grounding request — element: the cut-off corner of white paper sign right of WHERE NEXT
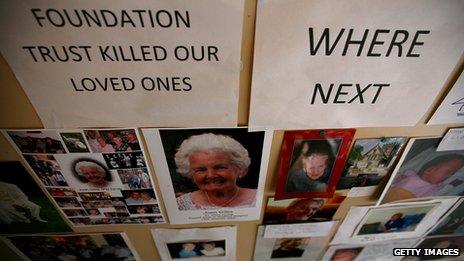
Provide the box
[427,73,464,125]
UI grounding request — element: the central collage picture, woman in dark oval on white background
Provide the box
[55,153,123,191]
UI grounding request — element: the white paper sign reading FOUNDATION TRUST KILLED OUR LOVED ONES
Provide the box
[0,0,244,128]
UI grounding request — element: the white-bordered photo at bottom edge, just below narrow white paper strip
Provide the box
[253,225,336,261]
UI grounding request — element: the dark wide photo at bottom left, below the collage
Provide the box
[7,233,138,260]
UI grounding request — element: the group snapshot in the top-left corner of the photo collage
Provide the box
[7,130,66,154]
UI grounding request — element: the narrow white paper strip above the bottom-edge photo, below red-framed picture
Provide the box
[263,221,334,238]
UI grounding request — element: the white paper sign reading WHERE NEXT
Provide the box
[250,0,464,129]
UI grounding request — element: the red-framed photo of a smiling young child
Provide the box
[275,129,356,199]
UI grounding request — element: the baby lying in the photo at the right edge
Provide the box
[384,154,464,202]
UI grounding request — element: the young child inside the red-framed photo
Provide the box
[285,141,333,192]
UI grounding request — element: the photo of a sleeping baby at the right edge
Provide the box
[380,138,464,203]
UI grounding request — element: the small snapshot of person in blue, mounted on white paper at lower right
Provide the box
[354,204,436,235]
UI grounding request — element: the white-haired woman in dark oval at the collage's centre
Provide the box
[74,160,112,188]
